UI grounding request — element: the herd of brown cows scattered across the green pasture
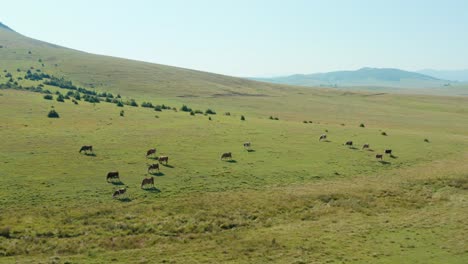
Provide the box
[79,134,392,198]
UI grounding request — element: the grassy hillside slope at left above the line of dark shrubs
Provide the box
[0,24,286,97]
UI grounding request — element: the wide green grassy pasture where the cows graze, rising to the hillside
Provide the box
[0,25,468,263]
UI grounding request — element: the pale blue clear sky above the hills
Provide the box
[0,0,468,77]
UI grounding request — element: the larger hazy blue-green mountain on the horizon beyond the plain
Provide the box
[253,68,448,88]
